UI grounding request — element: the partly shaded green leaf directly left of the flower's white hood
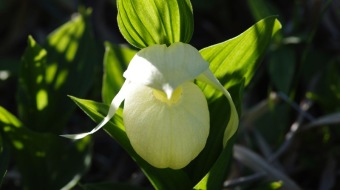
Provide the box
[102,42,137,104]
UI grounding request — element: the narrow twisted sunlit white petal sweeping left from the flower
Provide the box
[60,82,130,140]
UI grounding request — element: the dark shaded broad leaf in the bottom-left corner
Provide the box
[0,107,91,189]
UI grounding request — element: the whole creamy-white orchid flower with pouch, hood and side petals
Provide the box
[63,42,238,169]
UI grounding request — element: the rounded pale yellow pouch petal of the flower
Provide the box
[123,82,209,169]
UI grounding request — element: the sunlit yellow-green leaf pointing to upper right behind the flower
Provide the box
[200,17,281,101]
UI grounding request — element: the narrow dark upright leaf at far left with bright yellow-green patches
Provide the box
[18,36,49,128]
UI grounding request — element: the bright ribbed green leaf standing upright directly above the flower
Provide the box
[117,0,194,48]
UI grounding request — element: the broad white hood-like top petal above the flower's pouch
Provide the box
[124,42,209,98]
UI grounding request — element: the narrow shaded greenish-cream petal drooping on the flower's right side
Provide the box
[197,69,239,147]
